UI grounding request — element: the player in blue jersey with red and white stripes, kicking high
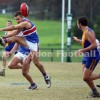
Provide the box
[0,11,51,87]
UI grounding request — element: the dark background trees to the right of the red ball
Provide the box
[25,0,100,20]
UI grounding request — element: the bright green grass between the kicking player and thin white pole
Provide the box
[36,21,65,46]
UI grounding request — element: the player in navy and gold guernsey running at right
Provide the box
[73,17,100,97]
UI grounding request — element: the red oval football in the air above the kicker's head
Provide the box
[20,3,29,17]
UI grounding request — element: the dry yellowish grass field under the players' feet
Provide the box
[0,62,100,100]
